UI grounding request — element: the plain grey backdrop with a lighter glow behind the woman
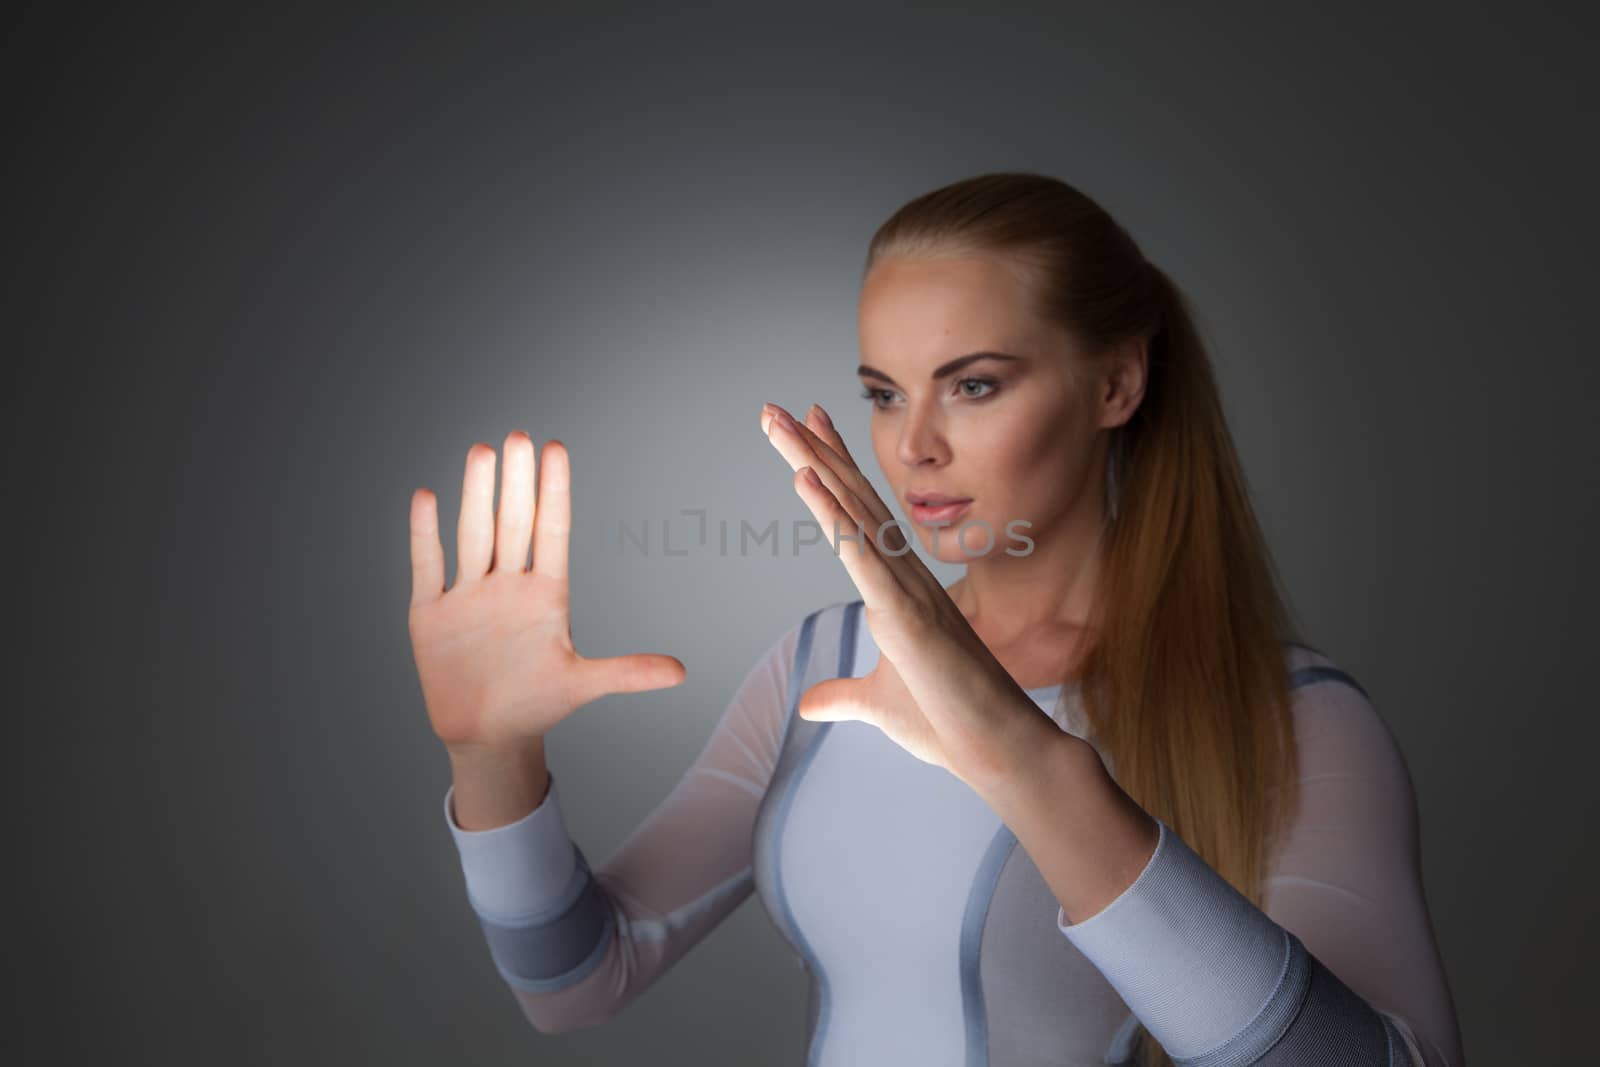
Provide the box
[15,3,1597,1067]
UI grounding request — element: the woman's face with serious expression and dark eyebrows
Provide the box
[858,256,1102,563]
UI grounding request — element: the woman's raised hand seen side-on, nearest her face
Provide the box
[762,403,1064,793]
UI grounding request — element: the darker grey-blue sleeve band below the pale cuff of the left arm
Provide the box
[478,853,616,989]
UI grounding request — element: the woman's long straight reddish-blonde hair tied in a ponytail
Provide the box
[866,173,1302,1067]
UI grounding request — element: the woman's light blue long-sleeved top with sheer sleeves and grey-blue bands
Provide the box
[445,600,1462,1067]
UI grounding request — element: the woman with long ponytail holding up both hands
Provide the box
[411,173,1462,1067]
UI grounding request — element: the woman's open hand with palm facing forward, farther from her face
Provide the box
[410,430,685,753]
